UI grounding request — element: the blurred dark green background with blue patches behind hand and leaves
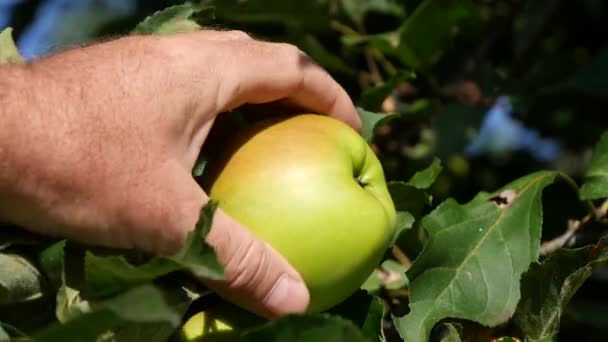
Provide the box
[0,0,608,341]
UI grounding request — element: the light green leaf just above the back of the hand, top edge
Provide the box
[132,2,213,35]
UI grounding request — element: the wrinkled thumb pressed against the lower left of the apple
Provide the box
[204,209,310,318]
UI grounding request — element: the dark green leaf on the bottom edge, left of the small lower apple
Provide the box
[35,285,180,341]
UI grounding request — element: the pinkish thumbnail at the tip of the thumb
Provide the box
[266,274,310,314]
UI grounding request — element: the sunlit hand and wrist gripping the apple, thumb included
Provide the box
[0,31,361,317]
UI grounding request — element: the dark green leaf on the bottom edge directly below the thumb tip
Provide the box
[243,315,369,342]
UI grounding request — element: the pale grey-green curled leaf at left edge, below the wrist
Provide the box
[0,253,44,305]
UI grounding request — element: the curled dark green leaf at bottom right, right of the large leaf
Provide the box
[513,238,608,341]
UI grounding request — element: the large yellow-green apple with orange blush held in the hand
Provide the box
[203,114,396,313]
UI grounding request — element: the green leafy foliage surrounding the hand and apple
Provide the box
[0,0,608,342]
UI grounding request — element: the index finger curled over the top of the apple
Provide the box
[218,40,361,130]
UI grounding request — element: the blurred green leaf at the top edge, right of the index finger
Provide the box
[343,0,481,71]
